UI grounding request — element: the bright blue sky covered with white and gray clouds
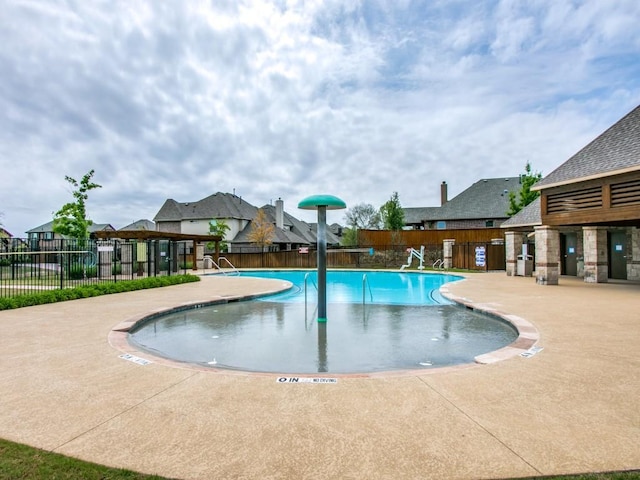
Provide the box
[0,0,640,236]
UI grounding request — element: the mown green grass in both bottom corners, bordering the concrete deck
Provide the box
[0,439,640,480]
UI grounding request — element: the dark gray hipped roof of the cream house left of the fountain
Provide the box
[153,192,258,222]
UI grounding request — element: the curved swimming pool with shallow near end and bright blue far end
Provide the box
[129,271,517,374]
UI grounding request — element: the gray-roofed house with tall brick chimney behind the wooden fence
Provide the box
[404,177,521,230]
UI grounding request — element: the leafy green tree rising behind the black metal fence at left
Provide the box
[53,170,102,240]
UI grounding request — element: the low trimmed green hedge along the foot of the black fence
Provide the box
[0,274,200,310]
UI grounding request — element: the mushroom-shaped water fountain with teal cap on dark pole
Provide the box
[298,195,347,322]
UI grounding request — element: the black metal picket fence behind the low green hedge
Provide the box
[0,238,194,297]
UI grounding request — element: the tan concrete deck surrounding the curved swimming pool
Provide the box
[0,273,640,479]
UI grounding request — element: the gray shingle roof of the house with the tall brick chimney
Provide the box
[404,177,520,224]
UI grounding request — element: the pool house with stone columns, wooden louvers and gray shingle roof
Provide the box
[504,106,640,285]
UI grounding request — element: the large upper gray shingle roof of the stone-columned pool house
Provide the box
[534,106,640,190]
